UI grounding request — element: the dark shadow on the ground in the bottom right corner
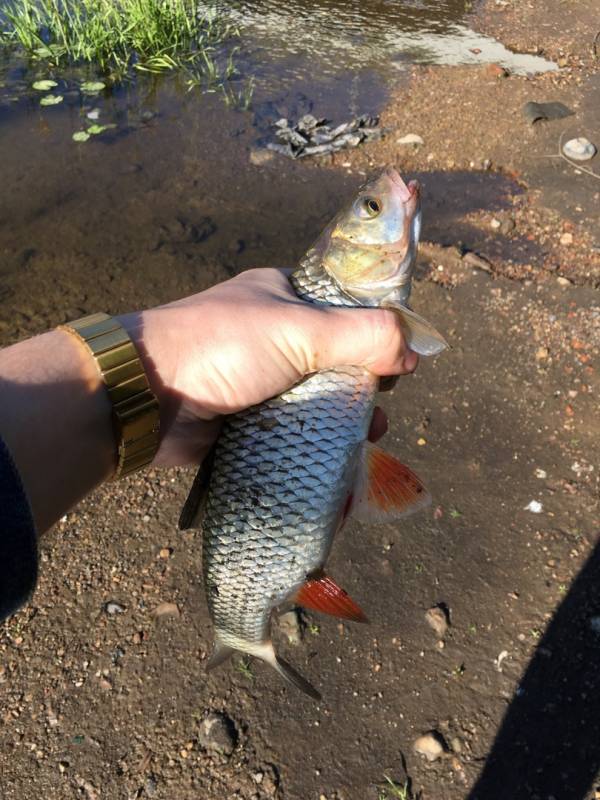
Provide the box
[468,547,600,800]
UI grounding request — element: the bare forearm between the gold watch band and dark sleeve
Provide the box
[0,330,116,533]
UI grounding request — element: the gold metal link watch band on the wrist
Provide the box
[59,313,160,478]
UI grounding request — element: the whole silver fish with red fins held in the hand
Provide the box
[179,167,447,699]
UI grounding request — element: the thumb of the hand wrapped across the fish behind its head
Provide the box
[311,307,419,375]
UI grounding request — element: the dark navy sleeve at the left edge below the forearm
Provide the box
[0,438,37,620]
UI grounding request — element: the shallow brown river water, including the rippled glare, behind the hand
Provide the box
[0,0,552,338]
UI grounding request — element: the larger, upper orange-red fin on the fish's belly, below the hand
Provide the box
[350,442,431,522]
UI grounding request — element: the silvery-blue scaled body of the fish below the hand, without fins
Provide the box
[203,367,376,646]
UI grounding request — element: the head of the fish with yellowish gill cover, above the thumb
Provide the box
[322,167,421,306]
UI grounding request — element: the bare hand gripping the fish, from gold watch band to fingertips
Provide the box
[120,269,418,466]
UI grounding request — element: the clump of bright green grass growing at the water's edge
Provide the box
[0,0,244,85]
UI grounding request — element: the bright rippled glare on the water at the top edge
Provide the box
[206,0,556,83]
